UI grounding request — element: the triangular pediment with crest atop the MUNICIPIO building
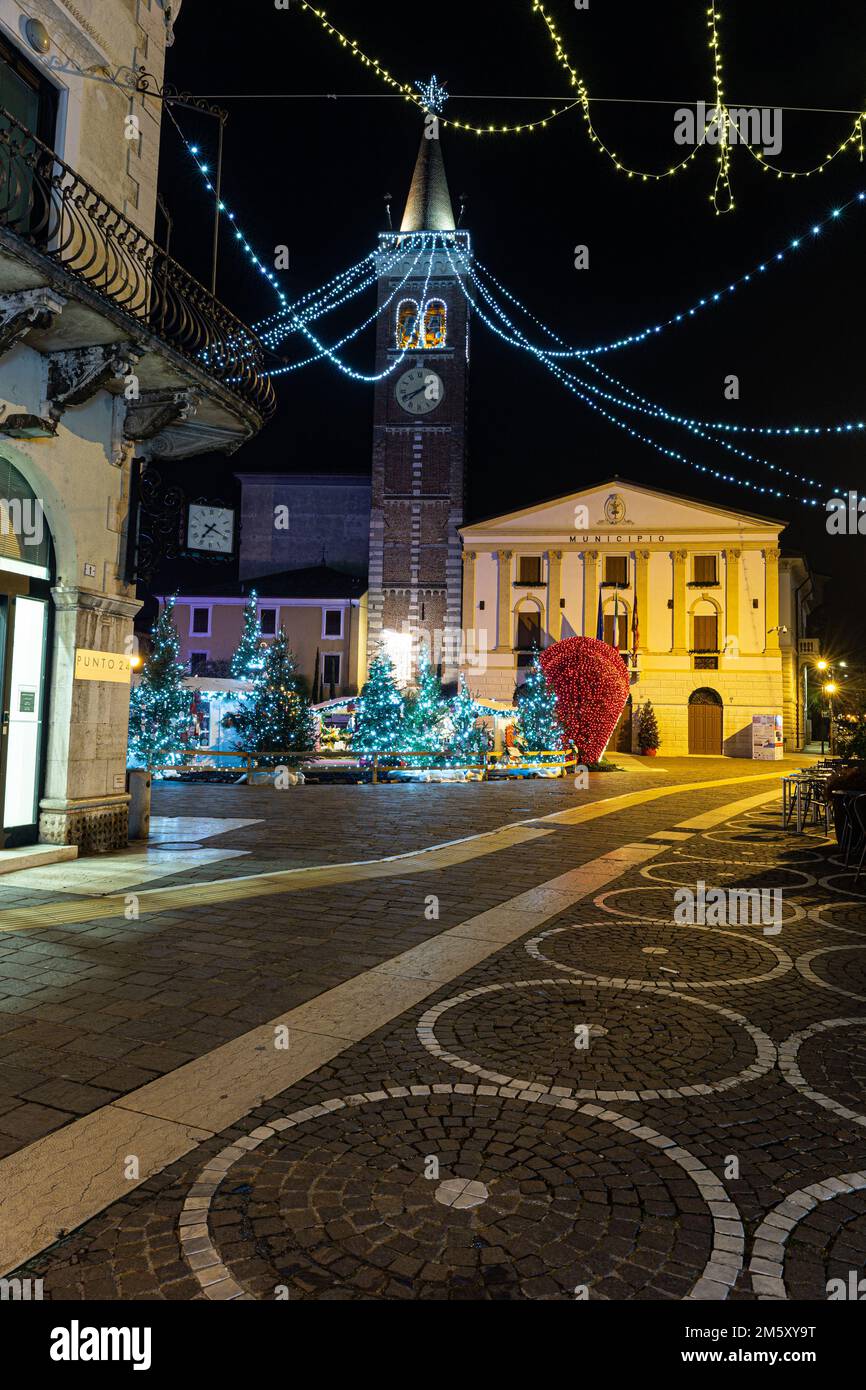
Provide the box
[461,478,785,545]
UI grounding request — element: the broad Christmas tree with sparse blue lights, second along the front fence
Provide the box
[235,627,316,766]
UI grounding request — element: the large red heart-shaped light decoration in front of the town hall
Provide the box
[541,637,628,763]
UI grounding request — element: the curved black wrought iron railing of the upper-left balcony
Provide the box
[0,107,274,418]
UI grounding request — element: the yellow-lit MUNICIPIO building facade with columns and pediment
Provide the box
[460,478,810,758]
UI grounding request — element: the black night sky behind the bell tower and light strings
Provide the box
[158,0,866,657]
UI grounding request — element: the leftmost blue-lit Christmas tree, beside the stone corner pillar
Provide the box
[128,599,192,767]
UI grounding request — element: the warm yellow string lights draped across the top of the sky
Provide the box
[294,0,866,213]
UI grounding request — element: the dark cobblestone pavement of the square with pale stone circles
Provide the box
[0,763,866,1300]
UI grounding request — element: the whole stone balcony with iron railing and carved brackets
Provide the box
[0,108,274,459]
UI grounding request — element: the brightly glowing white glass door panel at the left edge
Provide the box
[0,595,49,847]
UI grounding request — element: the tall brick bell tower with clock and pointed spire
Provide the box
[367,120,468,684]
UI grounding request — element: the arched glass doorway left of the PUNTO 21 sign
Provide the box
[0,455,54,849]
